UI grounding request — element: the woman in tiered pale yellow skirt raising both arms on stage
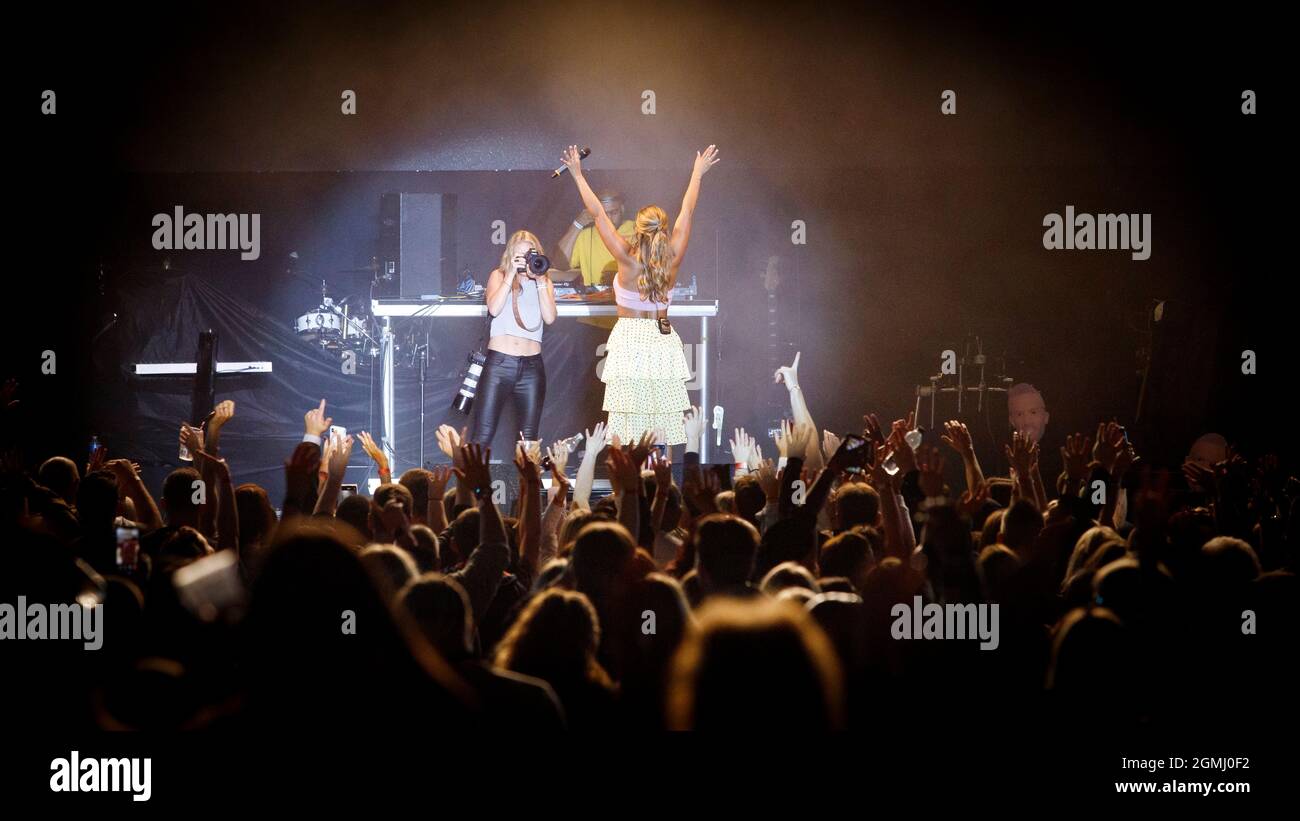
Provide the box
[563,145,719,444]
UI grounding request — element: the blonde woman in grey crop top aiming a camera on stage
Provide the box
[469,231,555,447]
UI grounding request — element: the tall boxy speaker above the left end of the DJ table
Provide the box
[374,194,458,299]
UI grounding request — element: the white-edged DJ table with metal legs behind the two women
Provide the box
[371,299,718,467]
